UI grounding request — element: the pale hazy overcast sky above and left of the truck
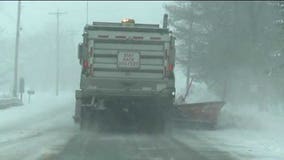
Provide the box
[0,1,172,90]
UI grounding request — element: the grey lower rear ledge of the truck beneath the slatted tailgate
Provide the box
[76,78,175,97]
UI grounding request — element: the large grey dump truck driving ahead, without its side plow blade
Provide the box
[73,14,225,132]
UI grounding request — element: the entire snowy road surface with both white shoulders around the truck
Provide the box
[0,93,284,160]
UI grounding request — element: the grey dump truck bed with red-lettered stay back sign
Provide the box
[81,22,174,96]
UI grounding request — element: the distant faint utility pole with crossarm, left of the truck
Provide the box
[49,9,66,96]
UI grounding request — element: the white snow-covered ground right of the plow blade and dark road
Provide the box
[175,107,284,160]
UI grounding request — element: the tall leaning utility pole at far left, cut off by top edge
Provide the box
[13,0,21,97]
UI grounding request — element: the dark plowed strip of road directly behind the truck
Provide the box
[47,133,235,160]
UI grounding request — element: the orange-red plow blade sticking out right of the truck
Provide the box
[175,101,225,128]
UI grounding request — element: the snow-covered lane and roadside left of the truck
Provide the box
[0,92,77,160]
